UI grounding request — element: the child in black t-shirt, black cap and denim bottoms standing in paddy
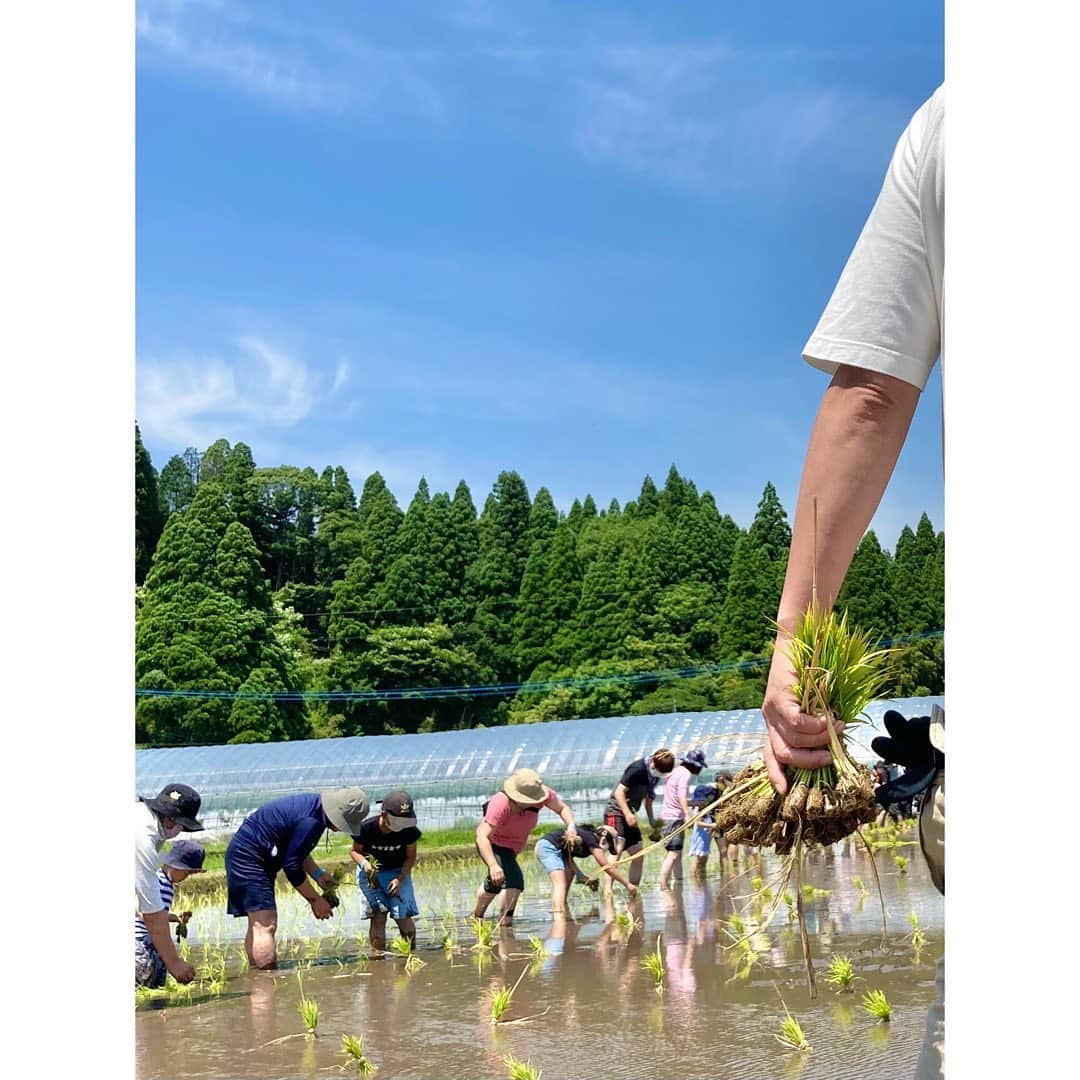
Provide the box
[349,791,423,951]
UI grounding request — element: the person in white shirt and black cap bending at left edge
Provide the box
[135,784,202,986]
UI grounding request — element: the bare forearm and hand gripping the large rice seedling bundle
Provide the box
[761,365,919,793]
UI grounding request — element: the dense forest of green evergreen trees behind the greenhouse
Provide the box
[135,428,945,745]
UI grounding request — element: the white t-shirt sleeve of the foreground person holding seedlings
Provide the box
[802,86,945,390]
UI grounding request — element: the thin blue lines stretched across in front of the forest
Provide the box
[135,630,944,703]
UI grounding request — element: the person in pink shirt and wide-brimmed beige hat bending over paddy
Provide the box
[473,769,577,924]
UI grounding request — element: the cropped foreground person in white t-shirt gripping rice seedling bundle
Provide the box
[761,86,945,1080]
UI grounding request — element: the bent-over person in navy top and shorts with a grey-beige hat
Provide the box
[225,787,368,970]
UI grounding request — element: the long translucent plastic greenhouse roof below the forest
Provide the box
[135,697,944,823]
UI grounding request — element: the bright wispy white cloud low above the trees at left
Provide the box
[136,337,327,446]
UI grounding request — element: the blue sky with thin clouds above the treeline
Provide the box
[136,0,943,546]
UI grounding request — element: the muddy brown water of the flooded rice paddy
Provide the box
[136,846,944,1080]
